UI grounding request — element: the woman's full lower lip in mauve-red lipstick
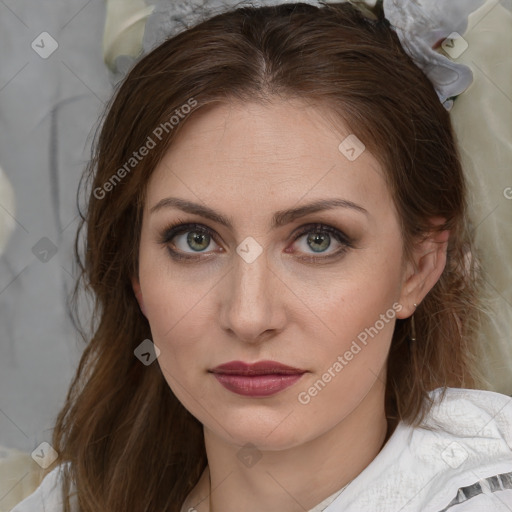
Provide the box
[214,373,304,396]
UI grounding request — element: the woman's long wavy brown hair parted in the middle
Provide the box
[53,2,481,512]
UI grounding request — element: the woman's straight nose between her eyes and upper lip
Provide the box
[220,244,285,343]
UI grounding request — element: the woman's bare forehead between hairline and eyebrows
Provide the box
[146,100,391,222]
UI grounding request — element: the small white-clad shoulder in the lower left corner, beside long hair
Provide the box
[11,463,78,512]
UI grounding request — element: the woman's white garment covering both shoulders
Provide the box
[11,388,512,512]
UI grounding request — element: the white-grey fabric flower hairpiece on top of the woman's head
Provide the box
[134,0,485,110]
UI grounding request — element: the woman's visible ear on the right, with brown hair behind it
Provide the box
[397,217,450,318]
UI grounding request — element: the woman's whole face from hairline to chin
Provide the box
[134,101,410,450]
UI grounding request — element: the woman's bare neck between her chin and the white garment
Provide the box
[186,381,393,512]
